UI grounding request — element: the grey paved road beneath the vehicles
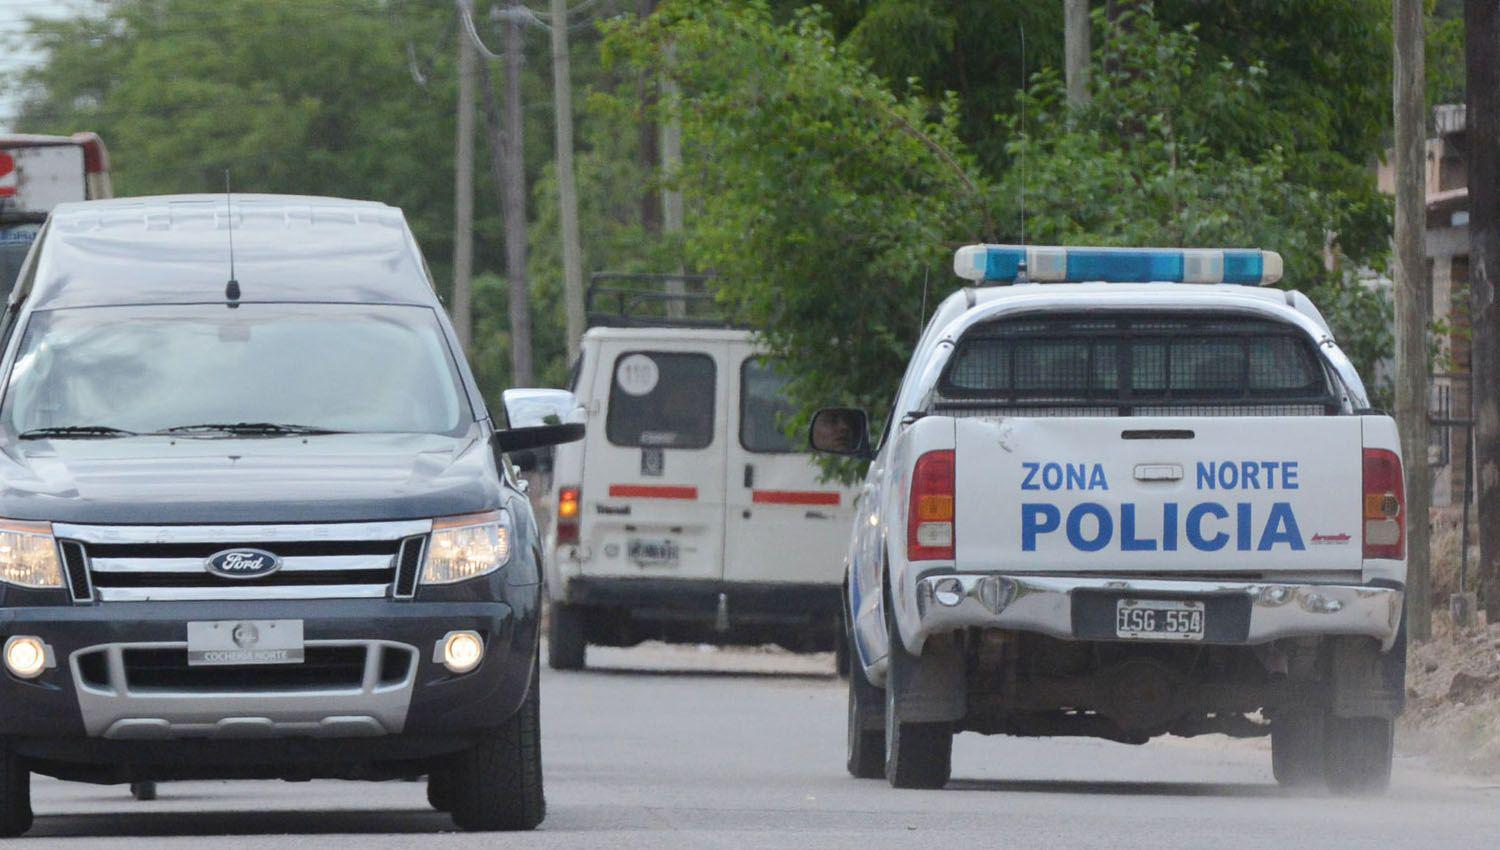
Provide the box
[26,648,1500,850]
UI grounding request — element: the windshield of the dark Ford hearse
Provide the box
[0,304,471,433]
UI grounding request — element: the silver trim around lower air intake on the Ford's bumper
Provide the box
[69,640,420,741]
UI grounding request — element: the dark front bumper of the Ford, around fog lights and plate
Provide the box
[0,600,536,759]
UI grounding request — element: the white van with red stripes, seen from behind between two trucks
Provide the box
[545,316,854,670]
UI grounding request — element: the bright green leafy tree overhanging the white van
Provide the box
[606,0,989,452]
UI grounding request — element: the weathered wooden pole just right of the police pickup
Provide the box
[1392,0,1433,640]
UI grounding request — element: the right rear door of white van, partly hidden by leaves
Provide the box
[725,343,854,585]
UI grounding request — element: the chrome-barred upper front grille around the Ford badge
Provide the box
[56,520,431,603]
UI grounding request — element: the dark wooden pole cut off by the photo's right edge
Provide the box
[1464,0,1500,622]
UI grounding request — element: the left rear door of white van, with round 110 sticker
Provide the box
[581,340,729,580]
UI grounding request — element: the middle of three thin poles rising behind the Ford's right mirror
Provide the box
[479,0,533,387]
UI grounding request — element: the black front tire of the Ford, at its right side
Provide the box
[447,664,548,832]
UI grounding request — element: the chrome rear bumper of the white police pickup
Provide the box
[909,573,1404,651]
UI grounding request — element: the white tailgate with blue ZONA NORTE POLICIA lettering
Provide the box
[956,417,1364,574]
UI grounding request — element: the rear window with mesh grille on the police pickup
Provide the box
[938,313,1340,415]
